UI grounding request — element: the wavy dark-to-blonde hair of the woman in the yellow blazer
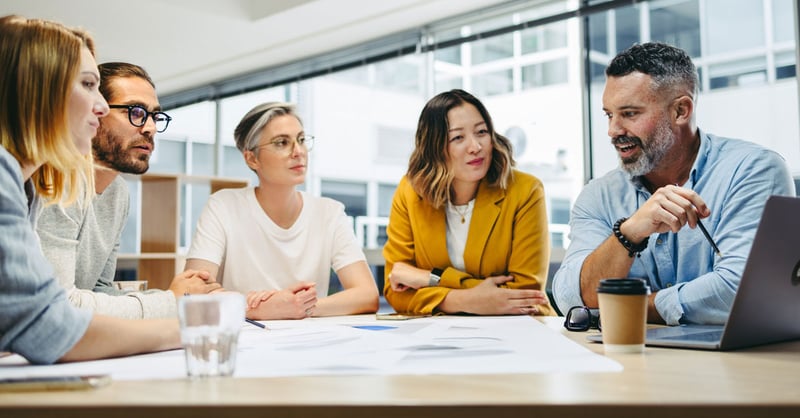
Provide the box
[406,89,514,209]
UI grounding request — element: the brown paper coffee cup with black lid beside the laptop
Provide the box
[597,279,650,353]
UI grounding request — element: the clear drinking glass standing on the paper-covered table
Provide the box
[178,292,245,378]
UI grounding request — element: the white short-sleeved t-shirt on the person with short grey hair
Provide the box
[187,187,366,297]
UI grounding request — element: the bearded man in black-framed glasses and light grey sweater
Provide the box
[37,63,220,318]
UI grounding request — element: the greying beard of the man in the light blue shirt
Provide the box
[611,117,675,177]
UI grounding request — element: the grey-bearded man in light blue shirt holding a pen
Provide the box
[553,42,794,325]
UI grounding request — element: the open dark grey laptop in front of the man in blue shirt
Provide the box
[590,196,800,350]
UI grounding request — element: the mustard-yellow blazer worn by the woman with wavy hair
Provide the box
[383,170,552,315]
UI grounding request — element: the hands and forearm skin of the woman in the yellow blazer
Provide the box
[388,262,549,315]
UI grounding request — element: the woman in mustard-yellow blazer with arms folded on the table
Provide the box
[383,90,552,315]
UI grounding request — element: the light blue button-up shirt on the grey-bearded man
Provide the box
[553,132,795,325]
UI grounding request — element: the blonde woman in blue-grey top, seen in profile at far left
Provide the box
[0,16,180,363]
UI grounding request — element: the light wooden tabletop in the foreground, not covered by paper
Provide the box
[0,318,800,418]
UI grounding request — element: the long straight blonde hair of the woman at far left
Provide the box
[0,15,94,203]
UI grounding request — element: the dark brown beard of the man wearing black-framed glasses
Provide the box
[92,124,153,174]
